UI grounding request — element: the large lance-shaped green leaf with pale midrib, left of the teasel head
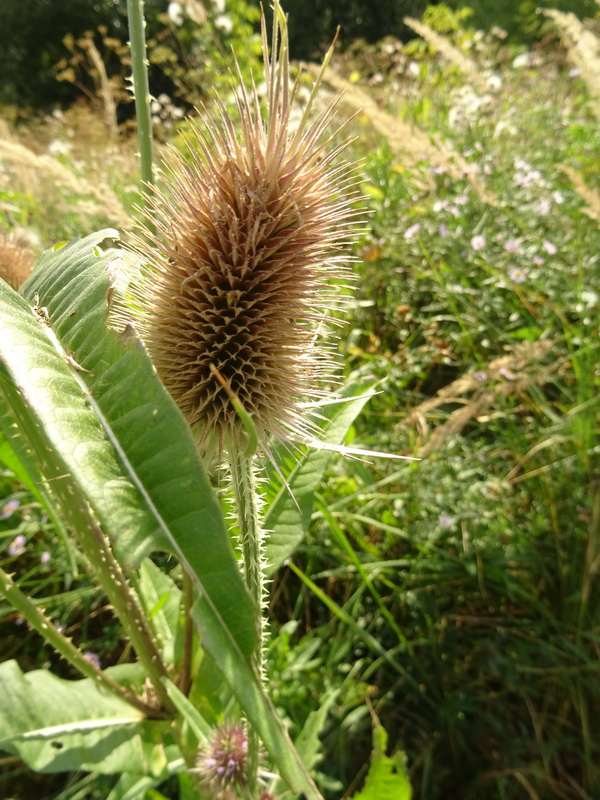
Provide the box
[14,230,255,656]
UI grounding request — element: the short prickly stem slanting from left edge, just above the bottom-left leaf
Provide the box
[0,568,162,718]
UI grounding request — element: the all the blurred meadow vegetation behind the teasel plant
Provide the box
[0,0,600,800]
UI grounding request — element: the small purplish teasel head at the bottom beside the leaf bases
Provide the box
[194,724,248,795]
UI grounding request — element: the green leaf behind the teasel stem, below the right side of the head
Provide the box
[264,380,373,574]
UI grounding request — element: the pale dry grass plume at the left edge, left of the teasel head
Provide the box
[0,140,131,230]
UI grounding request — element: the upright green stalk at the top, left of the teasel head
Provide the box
[127,0,154,195]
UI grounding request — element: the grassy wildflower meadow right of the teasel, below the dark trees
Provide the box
[264,7,600,800]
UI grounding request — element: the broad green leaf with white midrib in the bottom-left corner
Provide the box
[0,661,168,776]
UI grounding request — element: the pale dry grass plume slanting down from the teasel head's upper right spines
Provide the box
[314,66,500,207]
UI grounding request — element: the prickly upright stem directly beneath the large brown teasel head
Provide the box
[230,447,265,793]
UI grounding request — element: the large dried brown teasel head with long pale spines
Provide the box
[118,2,359,460]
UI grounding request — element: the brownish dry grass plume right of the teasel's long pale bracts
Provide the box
[398,341,562,458]
